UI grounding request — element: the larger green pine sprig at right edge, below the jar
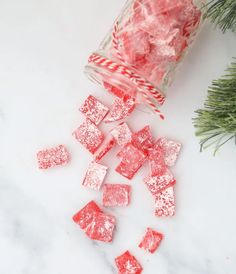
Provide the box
[193,62,236,153]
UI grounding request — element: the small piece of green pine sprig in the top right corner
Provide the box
[205,0,236,32]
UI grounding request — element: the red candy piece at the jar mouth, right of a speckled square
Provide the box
[104,95,135,123]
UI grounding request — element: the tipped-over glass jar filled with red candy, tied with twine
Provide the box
[86,0,203,116]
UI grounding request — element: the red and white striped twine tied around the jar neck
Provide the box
[89,22,165,119]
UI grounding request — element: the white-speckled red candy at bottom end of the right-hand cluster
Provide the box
[155,187,175,217]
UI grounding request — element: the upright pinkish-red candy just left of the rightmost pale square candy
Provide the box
[149,145,167,176]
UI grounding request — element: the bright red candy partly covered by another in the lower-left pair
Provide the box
[73,201,102,229]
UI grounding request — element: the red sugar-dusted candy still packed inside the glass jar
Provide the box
[111,0,202,86]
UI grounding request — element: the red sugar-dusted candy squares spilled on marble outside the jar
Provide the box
[37,95,181,273]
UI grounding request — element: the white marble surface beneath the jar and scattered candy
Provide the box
[0,0,236,274]
